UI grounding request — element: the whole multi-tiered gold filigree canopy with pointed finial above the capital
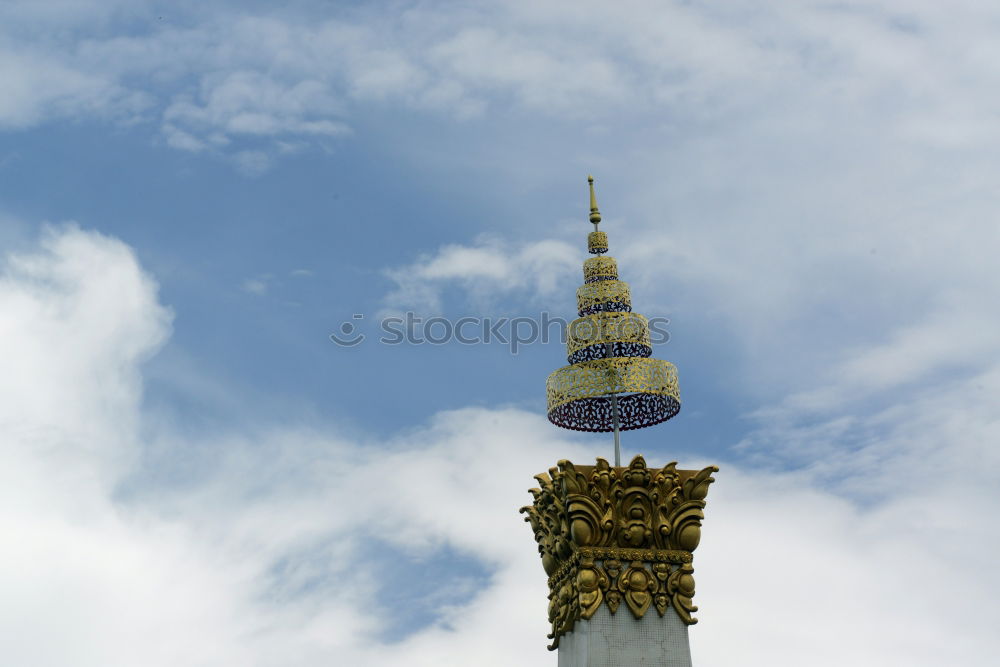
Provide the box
[546,177,681,444]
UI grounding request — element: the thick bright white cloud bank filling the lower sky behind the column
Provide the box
[0,228,1000,667]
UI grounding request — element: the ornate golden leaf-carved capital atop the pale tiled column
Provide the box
[521,456,719,650]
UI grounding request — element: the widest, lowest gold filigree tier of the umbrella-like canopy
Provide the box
[546,357,681,432]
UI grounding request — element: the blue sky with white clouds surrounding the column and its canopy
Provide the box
[0,0,1000,665]
